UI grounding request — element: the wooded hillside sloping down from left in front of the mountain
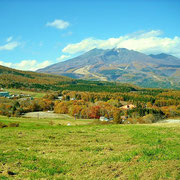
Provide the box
[0,66,138,92]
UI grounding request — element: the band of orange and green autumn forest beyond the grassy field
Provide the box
[0,89,180,124]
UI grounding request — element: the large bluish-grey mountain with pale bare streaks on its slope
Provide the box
[38,48,180,88]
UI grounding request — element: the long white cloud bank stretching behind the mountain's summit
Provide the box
[62,30,180,57]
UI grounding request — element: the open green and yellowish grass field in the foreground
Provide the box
[0,117,180,180]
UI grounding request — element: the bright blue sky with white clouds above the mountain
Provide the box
[0,0,180,70]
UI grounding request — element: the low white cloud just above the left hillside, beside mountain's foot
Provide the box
[0,60,51,71]
